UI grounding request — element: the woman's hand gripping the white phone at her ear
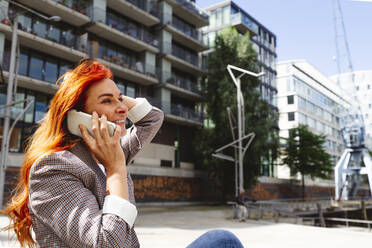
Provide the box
[79,111,126,176]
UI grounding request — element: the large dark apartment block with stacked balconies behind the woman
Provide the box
[0,0,208,201]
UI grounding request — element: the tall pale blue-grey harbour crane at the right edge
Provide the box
[333,0,372,200]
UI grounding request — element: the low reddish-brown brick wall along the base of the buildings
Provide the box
[4,167,369,202]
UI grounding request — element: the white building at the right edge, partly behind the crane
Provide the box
[331,70,372,149]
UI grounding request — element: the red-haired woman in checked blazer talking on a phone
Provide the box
[4,60,244,248]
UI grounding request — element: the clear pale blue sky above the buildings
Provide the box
[196,0,372,76]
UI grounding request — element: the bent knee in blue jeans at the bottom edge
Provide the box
[186,230,244,248]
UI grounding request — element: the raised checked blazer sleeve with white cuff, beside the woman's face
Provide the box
[121,98,164,164]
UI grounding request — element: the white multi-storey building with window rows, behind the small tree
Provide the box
[276,60,348,178]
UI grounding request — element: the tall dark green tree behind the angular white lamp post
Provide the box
[195,27,279,196]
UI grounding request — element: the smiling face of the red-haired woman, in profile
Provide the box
[83,78,128,135]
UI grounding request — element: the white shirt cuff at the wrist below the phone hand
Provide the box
[102,195,138,228]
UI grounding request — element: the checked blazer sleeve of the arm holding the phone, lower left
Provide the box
[29,154,139,248]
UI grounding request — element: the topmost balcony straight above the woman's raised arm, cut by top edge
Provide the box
[107,0,160,27]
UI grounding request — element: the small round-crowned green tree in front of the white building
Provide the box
[283,125,333,198]
